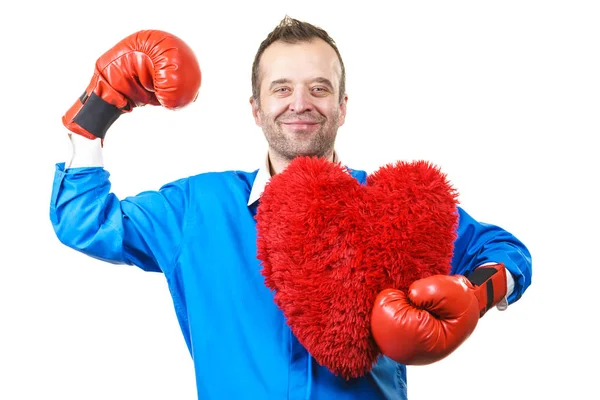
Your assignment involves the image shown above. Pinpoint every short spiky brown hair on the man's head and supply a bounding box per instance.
[252,15,346,104]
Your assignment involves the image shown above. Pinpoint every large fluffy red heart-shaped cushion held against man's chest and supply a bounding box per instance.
[256,157,458,379]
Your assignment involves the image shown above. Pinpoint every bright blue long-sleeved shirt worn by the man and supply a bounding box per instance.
[50,163,531,400]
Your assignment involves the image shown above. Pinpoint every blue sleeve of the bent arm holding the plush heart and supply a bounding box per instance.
[452,207,532,304]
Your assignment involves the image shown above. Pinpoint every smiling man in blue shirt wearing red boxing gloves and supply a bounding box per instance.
[50,17,531,400]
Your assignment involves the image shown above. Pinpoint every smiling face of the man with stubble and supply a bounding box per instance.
[250,39,348,161]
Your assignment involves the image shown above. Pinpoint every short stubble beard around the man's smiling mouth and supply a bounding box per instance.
[259,110,340,161]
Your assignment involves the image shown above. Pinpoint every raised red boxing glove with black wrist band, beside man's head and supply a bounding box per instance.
[62,30,202,139]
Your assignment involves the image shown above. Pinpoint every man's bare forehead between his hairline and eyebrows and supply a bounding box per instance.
[259,39,341,87]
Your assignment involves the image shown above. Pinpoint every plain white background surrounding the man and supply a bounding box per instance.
[0,0,600,400]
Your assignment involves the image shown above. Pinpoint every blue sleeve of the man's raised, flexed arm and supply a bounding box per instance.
[50,161,189,272]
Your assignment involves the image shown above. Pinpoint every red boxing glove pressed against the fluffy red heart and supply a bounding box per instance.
[371,264,507,365]
